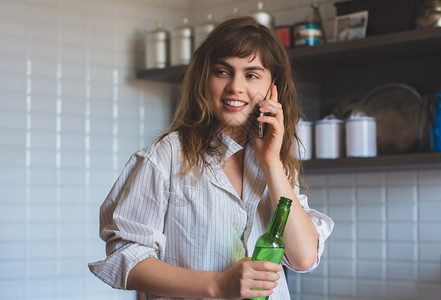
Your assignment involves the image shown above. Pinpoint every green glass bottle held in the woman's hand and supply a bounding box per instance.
[249,197,292,300]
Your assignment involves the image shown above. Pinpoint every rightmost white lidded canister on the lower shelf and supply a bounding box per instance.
[346,114,377,157]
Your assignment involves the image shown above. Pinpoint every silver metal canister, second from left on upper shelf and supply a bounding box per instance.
[170,18,193,66]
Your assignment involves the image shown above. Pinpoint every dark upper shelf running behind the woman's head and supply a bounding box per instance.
[137,28,441,83]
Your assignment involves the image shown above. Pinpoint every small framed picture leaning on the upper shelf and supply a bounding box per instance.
[335,10,369,42]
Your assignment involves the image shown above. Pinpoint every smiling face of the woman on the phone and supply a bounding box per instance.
[208,55,271,137]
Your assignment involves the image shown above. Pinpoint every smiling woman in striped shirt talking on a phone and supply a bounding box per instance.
[90,17,333,299]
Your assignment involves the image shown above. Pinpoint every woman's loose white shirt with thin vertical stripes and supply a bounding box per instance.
[89,133,333,299]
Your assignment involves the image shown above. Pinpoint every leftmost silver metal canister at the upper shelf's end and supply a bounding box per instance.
[145,22,170,69]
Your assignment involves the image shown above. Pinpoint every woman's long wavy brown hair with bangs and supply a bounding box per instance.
[159,17,301,186]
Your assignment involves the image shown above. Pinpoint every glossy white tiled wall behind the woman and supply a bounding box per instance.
[0,0,441,300]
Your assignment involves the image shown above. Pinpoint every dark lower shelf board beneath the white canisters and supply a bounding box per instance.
[303,152,441,175]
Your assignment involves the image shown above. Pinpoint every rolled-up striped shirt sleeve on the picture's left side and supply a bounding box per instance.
[89,153,168,289]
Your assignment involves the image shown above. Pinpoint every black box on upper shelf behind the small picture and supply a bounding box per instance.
[334,0,416,36]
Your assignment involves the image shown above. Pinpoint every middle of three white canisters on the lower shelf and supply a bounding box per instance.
[315,116,344,159]
